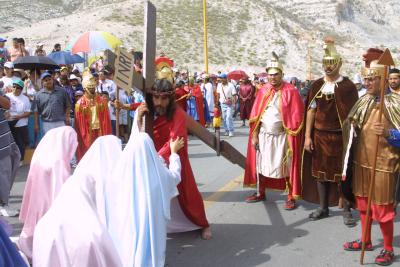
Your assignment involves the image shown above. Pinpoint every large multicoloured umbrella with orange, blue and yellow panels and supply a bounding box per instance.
[67,31,122,54]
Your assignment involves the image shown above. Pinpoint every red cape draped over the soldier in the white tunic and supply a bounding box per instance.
[243,82,304,197]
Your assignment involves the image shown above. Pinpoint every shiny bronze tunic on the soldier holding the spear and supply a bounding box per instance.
[353,108,399,205]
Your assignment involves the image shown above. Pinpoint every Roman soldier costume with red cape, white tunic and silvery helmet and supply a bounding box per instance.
[243,53,304,210]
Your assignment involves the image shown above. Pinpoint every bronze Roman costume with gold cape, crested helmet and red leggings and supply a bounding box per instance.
[343,48,400,266]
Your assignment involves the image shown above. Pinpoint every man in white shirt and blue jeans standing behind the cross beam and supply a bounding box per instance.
[217,74,237,137]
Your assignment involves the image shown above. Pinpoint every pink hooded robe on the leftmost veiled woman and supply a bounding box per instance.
[18,126,78,258]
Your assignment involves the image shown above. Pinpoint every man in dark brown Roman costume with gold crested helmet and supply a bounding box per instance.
[302,39,358,225]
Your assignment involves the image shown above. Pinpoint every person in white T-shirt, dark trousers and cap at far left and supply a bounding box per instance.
[6,80,31,165]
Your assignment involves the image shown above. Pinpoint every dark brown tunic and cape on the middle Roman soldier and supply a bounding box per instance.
[301,77,358,206]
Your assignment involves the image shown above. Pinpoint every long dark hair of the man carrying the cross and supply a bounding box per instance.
[146,79,176,121]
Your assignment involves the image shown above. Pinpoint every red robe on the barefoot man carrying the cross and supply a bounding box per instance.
[154,107,209,228]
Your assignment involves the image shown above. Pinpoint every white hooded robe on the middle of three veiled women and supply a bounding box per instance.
[32,135,122,267]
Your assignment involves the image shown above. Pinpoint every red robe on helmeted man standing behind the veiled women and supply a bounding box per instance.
[75,95,112,160]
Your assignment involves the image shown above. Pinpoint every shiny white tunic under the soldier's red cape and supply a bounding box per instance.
[256,94,291,178]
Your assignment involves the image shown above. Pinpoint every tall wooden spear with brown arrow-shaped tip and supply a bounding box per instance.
[360,49,394,265]
